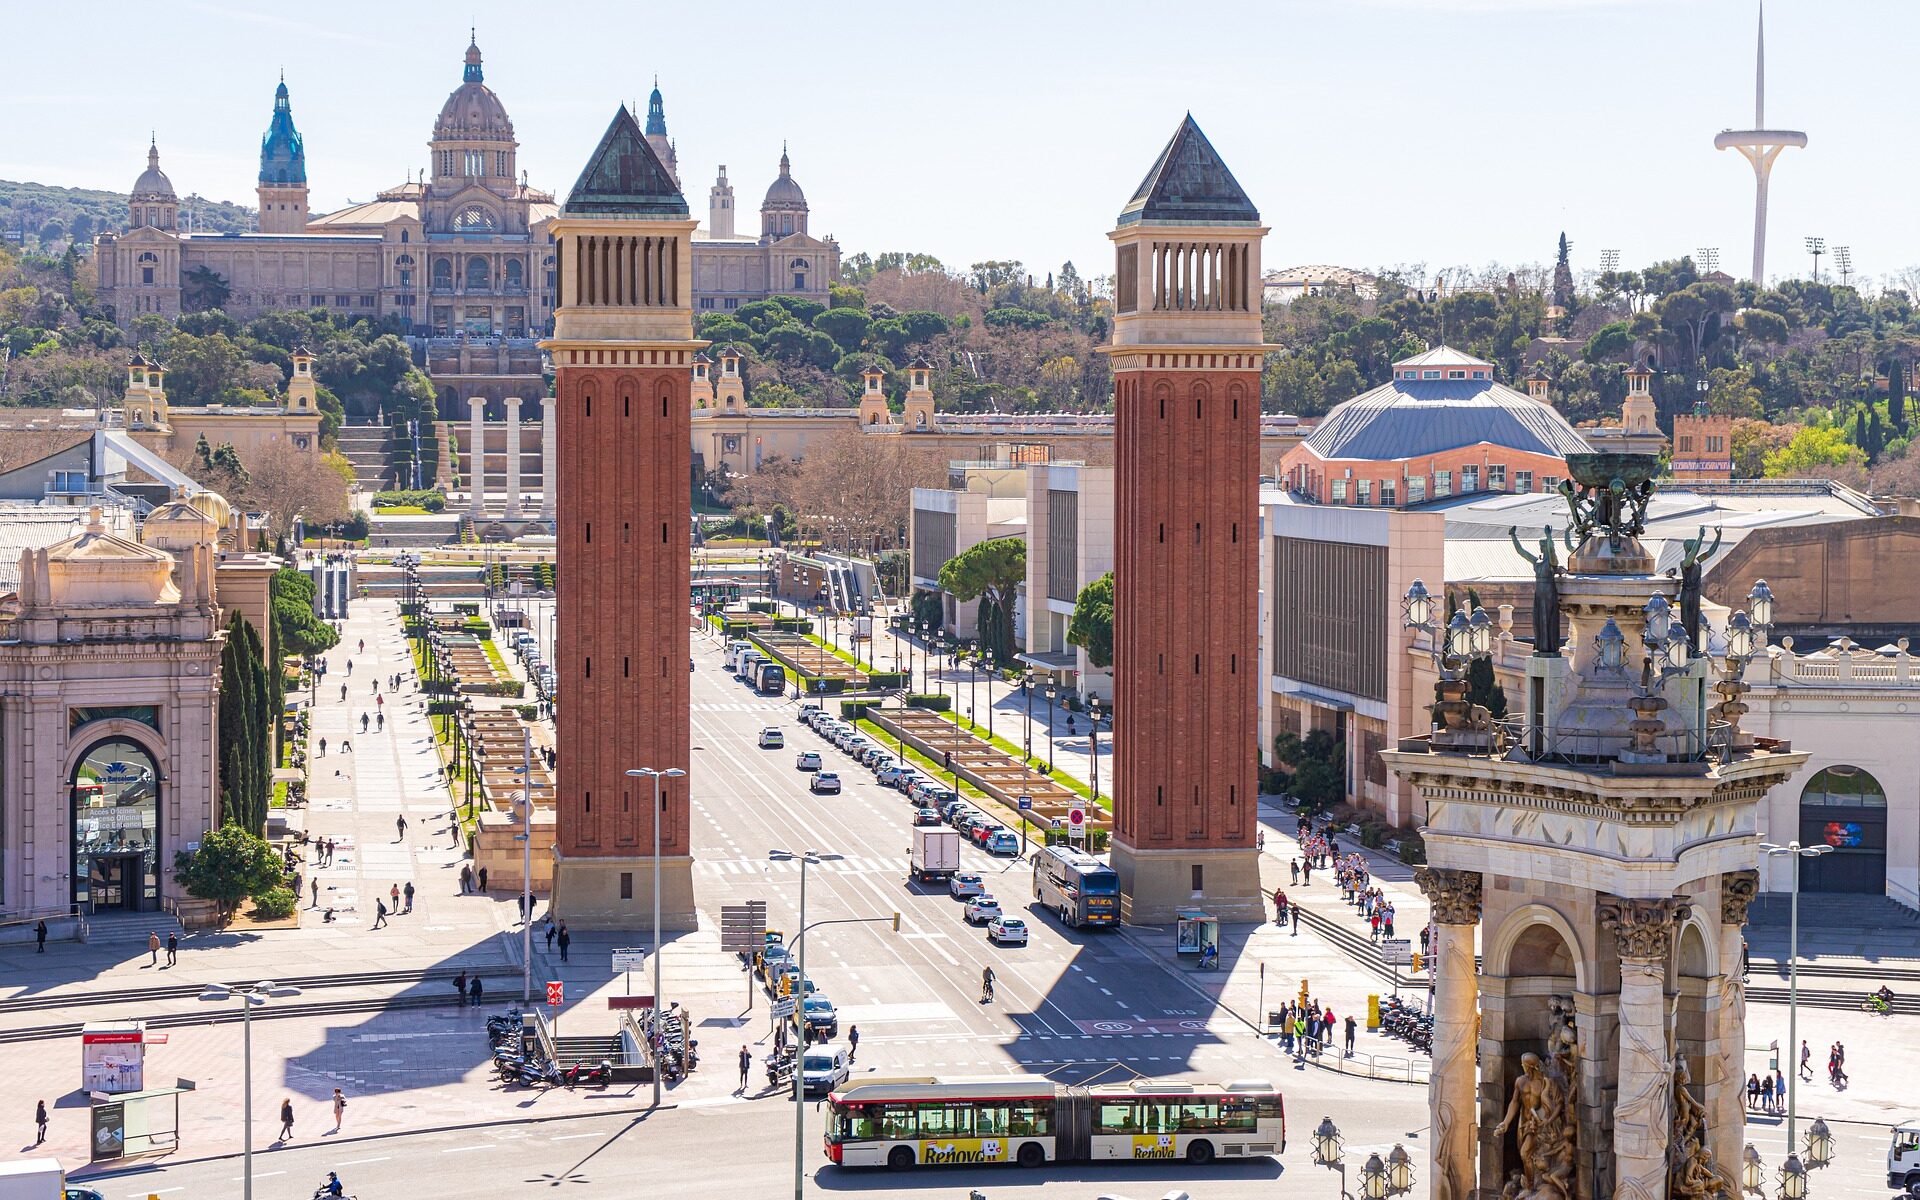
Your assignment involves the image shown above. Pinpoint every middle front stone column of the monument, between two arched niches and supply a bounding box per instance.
[1597,897,1688,1200]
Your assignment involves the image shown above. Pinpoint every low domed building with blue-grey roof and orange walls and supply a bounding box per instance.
[1281,346,1588,509]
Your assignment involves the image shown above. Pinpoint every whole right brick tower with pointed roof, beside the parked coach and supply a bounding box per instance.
[1108,117,1267,925]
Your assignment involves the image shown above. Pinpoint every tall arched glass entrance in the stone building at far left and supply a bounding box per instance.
[71,737,159,912]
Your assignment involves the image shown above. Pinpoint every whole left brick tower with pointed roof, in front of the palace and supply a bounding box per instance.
[541,108,705,929]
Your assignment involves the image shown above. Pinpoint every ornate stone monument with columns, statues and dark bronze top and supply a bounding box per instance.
[1382,455,1807,1200]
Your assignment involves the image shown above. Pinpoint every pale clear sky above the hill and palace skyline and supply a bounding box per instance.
[0,0,1920,288]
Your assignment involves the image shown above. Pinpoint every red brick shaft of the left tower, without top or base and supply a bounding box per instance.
[555,367,693,858]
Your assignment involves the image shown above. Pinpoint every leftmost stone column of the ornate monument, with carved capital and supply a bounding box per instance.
[1413,866,1480,1200]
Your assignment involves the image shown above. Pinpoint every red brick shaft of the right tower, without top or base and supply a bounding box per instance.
[1114,369,1260,849]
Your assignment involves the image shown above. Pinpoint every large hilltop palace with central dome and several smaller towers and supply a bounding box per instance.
[96,42,839,415]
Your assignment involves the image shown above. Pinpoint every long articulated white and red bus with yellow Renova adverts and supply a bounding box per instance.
[826,1075,1286,1171]
